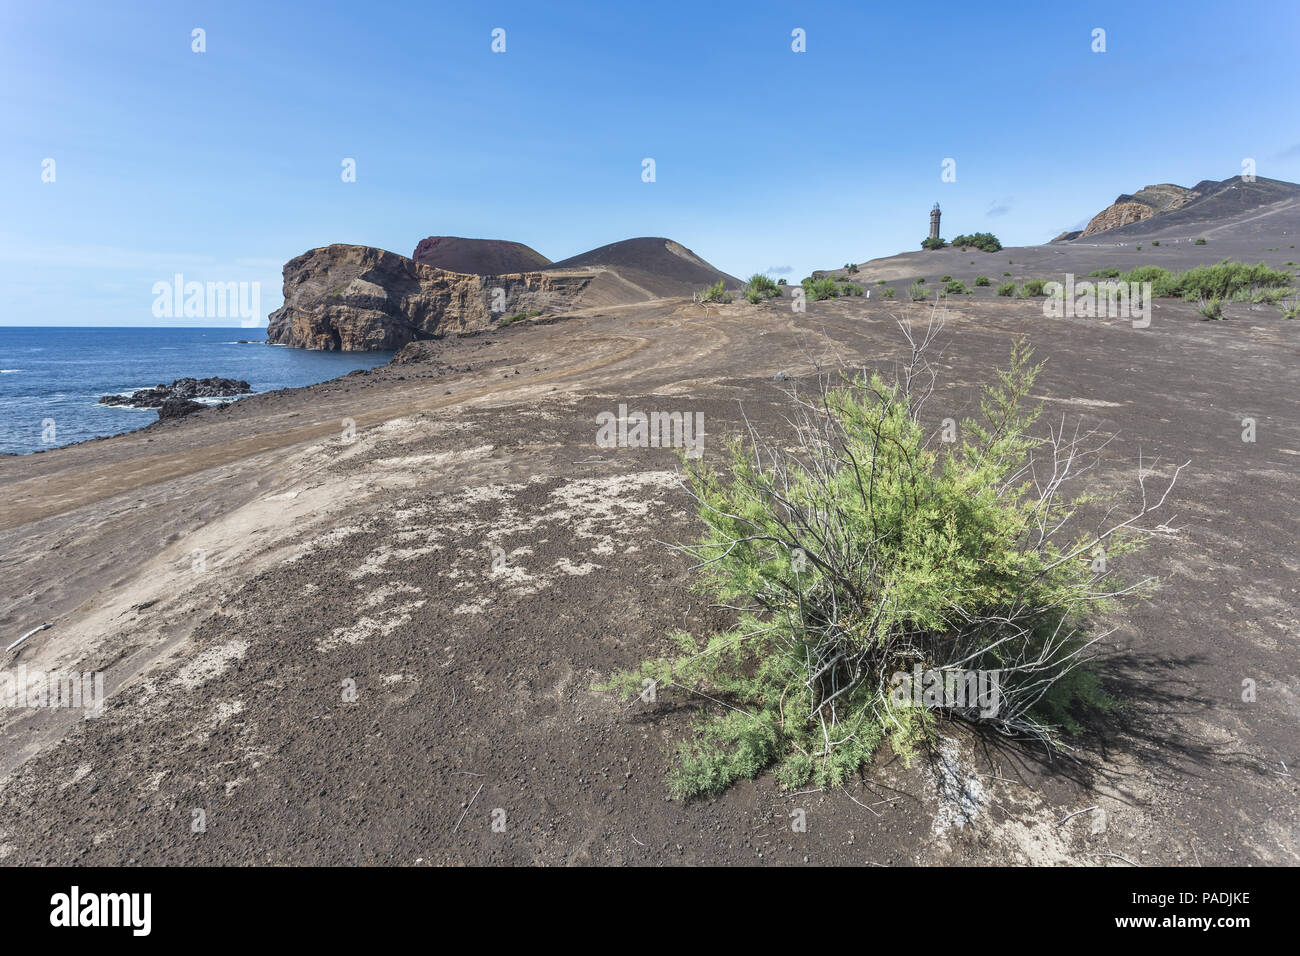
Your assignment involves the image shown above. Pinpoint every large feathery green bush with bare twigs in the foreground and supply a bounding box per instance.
[602,343,1177,799]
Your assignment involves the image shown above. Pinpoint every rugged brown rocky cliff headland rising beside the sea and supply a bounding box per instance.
[267,245,590,351]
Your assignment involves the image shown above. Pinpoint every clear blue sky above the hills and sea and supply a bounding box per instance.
[0,0,1300,325]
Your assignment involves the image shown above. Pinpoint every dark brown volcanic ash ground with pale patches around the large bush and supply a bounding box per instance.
[0,293,1300,865]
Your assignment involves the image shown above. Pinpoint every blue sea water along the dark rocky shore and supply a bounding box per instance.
[0,326,393,454]
